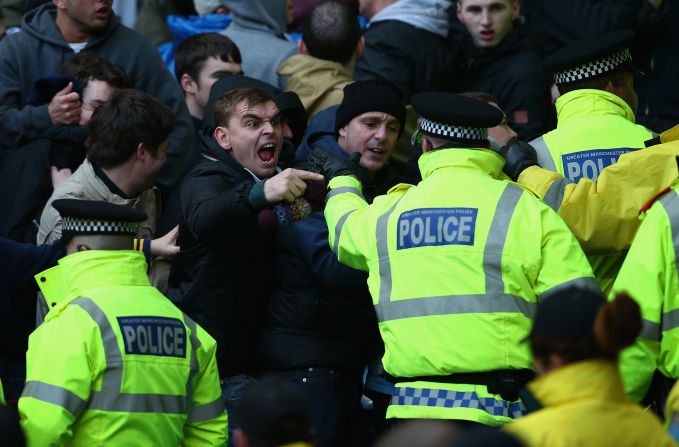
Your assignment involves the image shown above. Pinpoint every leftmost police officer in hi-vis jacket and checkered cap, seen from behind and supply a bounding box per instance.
[19,199,227,446]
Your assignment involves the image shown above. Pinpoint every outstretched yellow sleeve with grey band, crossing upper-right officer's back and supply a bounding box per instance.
[518,141,679,255]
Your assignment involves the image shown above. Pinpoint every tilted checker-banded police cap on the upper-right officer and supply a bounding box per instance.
[542,31,634,85]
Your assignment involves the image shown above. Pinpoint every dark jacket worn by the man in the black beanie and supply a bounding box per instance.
[259,211,379,374]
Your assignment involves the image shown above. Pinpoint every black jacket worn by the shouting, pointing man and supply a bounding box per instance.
[168,139,274,377]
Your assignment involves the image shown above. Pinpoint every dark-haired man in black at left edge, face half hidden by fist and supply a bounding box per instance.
[0,51,130,247]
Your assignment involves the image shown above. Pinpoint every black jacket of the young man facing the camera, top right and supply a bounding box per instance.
[452,20,556,141]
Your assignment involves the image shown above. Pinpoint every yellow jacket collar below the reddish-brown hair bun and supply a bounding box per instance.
[528,359,627,407]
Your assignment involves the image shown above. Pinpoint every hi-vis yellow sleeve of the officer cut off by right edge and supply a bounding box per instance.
[610,192,679,402]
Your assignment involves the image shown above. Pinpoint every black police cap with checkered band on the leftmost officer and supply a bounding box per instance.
[52,199,148,236]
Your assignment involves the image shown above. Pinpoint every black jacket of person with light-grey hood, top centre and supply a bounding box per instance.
[354,20,462,103]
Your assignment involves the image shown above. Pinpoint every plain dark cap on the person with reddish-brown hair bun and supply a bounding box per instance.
[530,287,606,340]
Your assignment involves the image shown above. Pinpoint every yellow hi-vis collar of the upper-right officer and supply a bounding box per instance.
[556,89,635,127]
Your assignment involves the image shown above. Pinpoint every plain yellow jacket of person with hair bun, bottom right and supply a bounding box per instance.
[503,360,676,447]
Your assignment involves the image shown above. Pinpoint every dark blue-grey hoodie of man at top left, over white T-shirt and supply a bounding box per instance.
[0,3,193,187]
